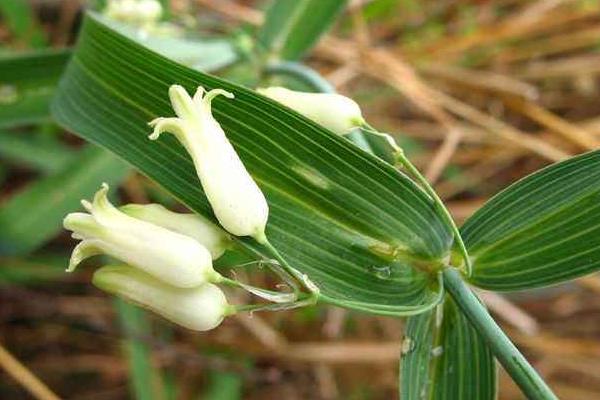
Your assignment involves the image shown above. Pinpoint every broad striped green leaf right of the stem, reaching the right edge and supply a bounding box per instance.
[462,151,600,290]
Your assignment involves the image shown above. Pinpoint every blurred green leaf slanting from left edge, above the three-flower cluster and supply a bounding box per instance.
[0,146,128,255]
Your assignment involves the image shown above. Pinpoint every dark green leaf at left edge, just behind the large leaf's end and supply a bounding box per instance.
[0,50,70,127]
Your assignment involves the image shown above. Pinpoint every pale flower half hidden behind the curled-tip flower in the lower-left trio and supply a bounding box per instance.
[119,204,231,260]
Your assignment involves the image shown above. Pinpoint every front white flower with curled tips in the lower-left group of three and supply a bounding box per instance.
[63,184,220,287]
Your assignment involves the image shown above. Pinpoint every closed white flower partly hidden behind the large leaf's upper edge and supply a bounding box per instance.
[256,87,364,135]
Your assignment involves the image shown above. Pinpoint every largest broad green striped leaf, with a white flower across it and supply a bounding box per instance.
[53,14,452,315]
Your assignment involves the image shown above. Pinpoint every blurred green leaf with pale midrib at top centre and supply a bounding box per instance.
[258,0,346,60]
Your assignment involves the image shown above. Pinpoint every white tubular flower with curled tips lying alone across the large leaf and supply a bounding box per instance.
[149,85,269,243]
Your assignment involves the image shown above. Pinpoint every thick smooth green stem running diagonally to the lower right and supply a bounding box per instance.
[443,268,558,400]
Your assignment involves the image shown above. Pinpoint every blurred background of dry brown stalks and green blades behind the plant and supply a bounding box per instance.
[0,0,600,400]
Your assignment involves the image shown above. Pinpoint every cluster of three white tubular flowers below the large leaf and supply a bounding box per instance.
[64,184,233,331]
